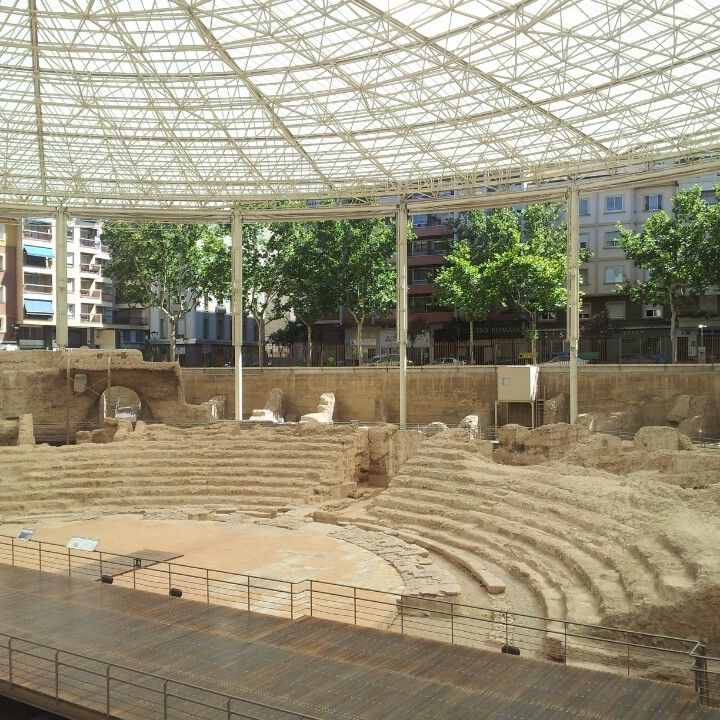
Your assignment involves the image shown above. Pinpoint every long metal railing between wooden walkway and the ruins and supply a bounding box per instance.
[0,535,720,705]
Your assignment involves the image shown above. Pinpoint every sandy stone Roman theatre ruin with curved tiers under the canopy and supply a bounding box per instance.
[0,350,720,680]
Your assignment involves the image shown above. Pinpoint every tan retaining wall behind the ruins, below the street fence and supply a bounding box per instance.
[183,365,720,434]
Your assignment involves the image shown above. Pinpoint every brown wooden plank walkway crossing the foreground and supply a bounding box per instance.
[0,565,720,720]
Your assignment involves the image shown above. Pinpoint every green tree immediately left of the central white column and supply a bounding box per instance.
[336,218,396,365]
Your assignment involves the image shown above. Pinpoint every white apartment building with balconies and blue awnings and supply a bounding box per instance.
[5,218,147,349]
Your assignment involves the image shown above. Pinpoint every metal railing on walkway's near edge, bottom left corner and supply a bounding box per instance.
[0,633,326,720]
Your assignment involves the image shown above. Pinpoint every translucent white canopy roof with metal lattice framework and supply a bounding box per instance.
[0,0,720,208]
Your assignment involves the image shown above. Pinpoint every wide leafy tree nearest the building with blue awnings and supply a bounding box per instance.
[103,221,224,360]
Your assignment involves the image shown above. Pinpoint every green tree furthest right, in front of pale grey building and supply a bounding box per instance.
[618,185,720,363]
